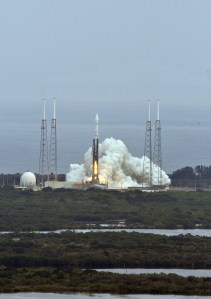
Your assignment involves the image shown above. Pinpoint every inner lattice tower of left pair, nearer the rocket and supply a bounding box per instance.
[49,98,57,181]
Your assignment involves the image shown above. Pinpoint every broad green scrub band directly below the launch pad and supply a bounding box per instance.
[0,189,211,231]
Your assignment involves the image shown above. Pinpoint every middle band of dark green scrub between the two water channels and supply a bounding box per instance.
[0,232,211,269]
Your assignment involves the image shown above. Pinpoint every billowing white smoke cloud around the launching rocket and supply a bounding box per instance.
[66,138,170,188]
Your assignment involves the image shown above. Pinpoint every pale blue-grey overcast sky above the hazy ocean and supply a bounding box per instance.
[0,0,211,123]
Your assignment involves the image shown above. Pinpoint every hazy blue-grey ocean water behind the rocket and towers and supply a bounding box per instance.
[0,120,211,173]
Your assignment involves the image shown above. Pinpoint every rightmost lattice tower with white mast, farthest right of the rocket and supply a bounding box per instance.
[153,100,163,186]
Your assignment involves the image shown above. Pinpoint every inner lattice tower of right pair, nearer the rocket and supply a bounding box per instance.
[143,100,152,187]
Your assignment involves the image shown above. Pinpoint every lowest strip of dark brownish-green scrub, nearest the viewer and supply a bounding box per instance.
[0,267,211,295]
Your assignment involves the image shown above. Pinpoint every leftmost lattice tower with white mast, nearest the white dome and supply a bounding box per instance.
[39,99,48,186]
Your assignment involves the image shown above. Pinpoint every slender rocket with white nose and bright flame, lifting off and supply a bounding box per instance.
[92,114,99,184]
